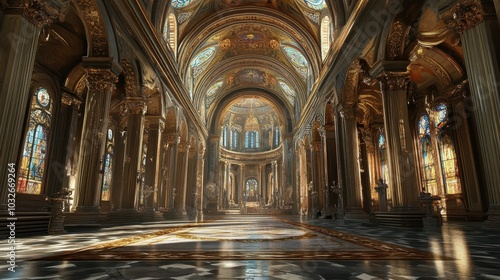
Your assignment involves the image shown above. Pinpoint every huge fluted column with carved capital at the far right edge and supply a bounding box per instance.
[454,1,500,226]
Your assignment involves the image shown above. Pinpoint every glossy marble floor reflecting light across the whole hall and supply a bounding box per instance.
[0,215,500,280]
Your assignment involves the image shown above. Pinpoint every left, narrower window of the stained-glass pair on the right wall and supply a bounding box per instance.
[418,114,438,195]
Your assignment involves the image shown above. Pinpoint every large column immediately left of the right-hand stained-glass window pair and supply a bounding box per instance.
[375,68,420,210]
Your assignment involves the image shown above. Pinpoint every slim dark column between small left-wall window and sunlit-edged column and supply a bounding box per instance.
[111,107,128,211]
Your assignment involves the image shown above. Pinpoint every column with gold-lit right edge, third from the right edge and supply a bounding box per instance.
[339,106,368,219]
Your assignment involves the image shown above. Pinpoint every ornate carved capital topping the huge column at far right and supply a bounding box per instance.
[443,0,484,45]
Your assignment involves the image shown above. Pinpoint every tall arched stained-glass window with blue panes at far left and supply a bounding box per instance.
[17,87,52,194]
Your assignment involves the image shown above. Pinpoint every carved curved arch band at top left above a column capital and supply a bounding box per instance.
[76,0,109,57]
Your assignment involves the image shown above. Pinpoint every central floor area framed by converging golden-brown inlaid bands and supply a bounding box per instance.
[38,216,450,261]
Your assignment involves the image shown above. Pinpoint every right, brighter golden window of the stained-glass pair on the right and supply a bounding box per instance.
[434,103,462,194]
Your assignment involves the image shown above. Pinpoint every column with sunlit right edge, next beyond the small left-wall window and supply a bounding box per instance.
[119,97,146,212]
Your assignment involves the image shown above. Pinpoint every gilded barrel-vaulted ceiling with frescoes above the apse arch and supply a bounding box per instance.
[171,0,329,127]
